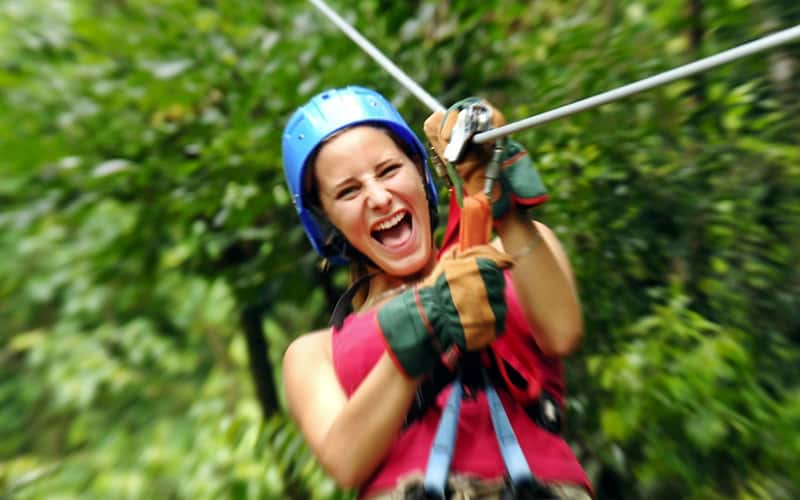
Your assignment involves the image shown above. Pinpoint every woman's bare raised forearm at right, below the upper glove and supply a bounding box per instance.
[495,210,583,356]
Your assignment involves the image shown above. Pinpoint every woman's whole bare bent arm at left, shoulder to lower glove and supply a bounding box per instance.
[283,330,419,488]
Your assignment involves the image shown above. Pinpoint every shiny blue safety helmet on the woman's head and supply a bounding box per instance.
[283,86,439,264]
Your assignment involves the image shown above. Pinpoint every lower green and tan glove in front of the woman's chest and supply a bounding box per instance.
[377,245,512,377]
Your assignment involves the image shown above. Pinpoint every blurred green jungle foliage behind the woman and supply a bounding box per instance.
[0,0,800,500]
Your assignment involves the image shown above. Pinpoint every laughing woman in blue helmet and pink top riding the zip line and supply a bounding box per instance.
[283,87,591,498]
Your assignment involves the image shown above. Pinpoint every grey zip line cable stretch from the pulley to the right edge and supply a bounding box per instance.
[472,25,800,144]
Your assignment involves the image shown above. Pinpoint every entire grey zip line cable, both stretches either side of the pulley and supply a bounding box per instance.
[309,0,800,144]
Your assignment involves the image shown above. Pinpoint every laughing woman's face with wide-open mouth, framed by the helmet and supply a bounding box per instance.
[314,126,433,276]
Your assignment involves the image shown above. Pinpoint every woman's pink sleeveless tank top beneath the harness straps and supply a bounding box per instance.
[333,274,591,497]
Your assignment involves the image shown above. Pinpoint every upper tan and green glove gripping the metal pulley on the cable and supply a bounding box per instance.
[423,97,548,219]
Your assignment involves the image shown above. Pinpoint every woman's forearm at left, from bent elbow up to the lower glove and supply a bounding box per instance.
[318,354,419,487]
